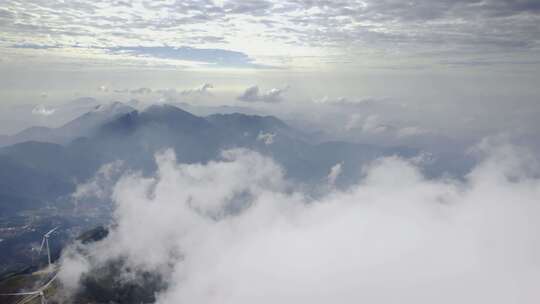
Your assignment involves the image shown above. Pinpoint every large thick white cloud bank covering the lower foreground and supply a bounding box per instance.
[60,144,540,304]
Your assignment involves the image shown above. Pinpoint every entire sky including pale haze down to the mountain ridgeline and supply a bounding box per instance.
[0,0,540,147]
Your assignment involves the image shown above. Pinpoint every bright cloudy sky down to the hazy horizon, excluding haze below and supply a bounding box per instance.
[0,0,540,103]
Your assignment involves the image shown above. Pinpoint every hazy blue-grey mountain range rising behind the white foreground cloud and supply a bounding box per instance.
[0,103,430,217]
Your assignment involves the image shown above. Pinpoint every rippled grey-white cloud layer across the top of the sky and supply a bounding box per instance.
[0,0,540,68]
